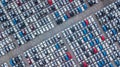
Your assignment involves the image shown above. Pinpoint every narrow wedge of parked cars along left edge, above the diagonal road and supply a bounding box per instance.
[0,6,16,57]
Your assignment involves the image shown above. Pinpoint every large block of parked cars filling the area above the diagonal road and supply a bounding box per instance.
[0,0,98,56]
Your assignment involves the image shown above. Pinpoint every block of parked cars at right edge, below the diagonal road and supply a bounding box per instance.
[95,0,120,44]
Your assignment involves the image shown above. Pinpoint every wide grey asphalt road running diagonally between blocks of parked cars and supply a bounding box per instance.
[0,0,118,67]
